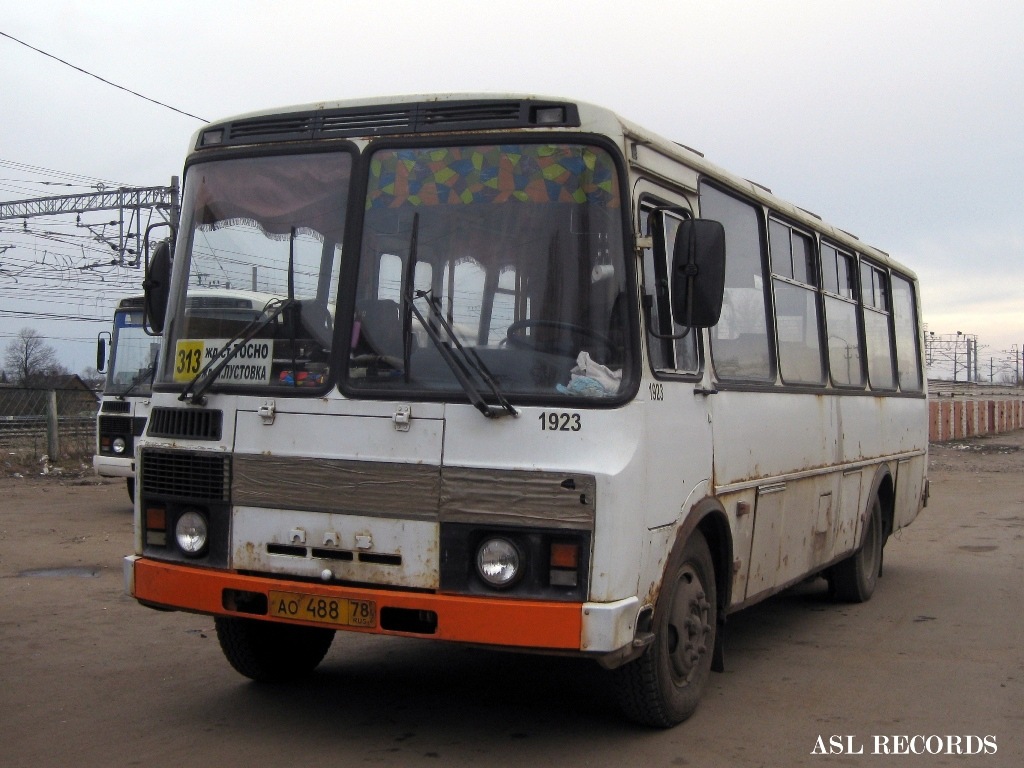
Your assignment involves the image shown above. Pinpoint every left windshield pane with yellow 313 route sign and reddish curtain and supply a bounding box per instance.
[161,153,352,389]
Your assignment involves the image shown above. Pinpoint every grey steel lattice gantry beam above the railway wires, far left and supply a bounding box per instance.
[0,176,180,267]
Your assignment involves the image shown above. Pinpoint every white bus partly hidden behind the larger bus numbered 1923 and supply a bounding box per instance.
[92,296,160,500]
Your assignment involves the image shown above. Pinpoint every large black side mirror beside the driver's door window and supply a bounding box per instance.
[672,219,725,328]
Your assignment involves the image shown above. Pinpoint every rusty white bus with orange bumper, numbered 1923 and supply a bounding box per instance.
[125,95,928,727]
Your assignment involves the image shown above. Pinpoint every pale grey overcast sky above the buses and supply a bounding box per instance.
[0,0,1024,380]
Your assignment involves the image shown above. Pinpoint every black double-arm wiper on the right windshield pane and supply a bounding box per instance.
[402,213,519,419]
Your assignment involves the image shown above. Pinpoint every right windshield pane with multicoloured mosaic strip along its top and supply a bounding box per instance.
[345,143,631,401]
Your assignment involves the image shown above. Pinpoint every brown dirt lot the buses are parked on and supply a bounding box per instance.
[0,432,1024,768]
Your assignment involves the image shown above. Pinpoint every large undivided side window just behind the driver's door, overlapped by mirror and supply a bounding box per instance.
[700,182,775,382]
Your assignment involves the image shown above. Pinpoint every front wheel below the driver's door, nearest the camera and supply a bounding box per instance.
[614,530,718,728]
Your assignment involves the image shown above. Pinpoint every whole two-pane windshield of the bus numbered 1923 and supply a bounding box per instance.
[162,143,633,403]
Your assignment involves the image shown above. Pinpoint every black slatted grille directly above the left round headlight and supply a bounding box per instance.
[139,450,231,502]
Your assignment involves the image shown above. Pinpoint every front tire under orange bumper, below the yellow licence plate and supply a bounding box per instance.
[214,616,334,683]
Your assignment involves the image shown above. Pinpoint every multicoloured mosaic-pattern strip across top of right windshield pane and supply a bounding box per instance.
[367,144,620,209]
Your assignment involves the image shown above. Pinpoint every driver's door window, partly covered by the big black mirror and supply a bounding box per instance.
[640,203,700,374]
